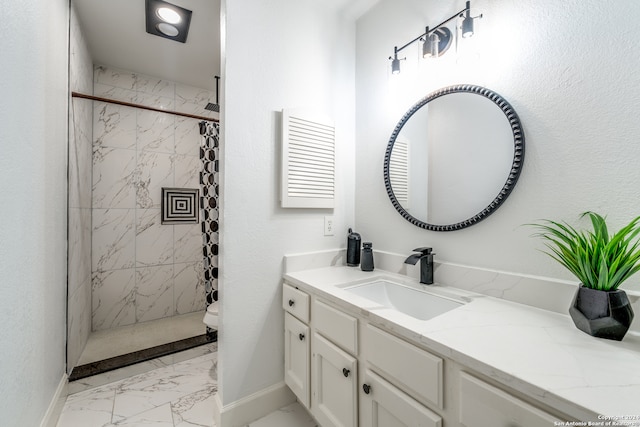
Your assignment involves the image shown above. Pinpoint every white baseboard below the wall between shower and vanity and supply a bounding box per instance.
[214,382,296,427]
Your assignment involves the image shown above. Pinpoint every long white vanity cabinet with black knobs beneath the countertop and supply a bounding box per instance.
[283,270,597,427]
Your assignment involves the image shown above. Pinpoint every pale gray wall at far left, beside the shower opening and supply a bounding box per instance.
[0,0,69,426]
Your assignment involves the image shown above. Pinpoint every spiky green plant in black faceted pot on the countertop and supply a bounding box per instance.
[531,212,640,341]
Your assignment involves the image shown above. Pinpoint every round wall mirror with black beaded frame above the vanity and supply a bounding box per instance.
[384,85,524,231]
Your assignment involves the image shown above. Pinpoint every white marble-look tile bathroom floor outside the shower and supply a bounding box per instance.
[57,343,316,427]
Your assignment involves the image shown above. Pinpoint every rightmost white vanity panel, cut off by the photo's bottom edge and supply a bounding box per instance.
[460,372,560,427]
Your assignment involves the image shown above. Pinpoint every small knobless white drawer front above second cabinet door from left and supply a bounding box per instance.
[312,300,358,355]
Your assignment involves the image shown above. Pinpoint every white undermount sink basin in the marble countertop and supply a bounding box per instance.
[344,280,463,320]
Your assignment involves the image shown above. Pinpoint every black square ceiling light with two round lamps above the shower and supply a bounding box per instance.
[145,0,192,43]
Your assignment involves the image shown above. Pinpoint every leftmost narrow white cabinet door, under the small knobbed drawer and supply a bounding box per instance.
[284,313,310,408]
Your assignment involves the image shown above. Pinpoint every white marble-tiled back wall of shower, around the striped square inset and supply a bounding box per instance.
[92,66,215,330]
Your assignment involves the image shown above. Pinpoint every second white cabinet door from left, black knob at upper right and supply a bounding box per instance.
[311,333,358,427]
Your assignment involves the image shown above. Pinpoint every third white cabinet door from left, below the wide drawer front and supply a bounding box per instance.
[360,369,442,427]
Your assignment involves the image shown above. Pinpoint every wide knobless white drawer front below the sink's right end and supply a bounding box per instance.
[363,325,443,408]
